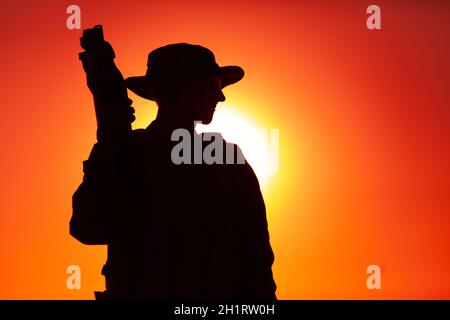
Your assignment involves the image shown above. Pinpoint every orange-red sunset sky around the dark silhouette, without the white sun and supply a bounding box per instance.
[0,0,450,299]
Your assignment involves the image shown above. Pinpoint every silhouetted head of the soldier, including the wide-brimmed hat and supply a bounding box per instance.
[126,43,244,124]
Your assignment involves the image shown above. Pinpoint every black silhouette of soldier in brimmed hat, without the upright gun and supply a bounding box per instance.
[70,43,276,299]
